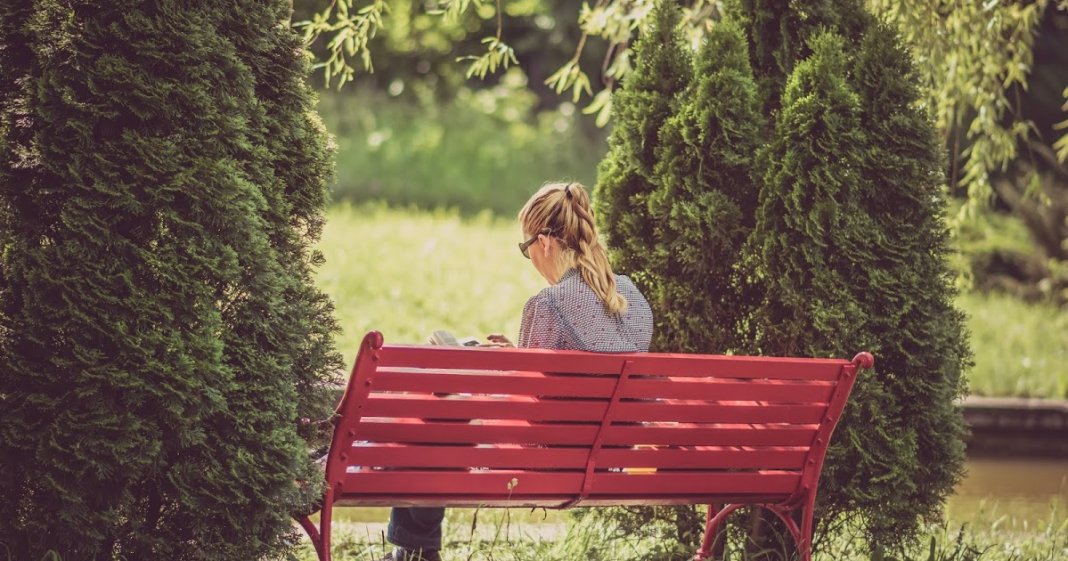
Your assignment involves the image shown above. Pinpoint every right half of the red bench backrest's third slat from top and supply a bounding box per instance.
[612,401,827,424]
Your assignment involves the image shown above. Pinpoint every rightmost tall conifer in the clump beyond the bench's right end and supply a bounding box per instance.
[827,24,971,543]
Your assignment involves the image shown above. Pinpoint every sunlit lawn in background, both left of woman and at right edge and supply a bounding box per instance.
[318,205,1068,398]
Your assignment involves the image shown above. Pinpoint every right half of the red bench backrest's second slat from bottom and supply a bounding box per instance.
[597,447,807,470]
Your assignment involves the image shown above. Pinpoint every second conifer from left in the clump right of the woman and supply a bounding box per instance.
[646,19,764,353]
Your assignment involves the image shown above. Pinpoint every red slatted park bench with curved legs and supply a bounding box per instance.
[300,332,874,561]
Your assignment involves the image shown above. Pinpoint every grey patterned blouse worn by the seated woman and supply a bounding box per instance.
[518,268,653,353]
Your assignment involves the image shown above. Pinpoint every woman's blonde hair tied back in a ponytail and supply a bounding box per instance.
[519,183,627,314]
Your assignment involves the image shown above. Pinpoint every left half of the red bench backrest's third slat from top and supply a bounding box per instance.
[362,394,608,421]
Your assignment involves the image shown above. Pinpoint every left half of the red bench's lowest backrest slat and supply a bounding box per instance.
[342,470,583,498]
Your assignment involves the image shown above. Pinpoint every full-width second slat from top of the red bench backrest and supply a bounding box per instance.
[372,369,834,403]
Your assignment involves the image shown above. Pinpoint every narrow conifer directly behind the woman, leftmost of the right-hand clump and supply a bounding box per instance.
[594,2,690,279]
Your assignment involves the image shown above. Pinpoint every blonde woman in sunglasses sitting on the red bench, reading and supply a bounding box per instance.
[382,183,653,561]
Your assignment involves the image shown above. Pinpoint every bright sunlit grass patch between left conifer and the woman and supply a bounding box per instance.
[309,205,546,364]
